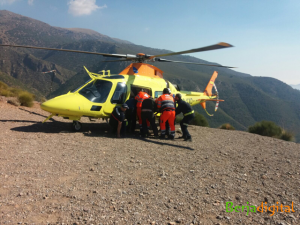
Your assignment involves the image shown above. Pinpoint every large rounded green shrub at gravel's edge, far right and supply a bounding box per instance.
[248,121,282,138]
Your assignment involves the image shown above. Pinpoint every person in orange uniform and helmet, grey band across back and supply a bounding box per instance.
[156,88,175,139]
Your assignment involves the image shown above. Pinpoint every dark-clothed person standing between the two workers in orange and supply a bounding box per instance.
[141,97,158,137]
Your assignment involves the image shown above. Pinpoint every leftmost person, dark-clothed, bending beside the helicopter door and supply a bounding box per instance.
[109,103,129,138]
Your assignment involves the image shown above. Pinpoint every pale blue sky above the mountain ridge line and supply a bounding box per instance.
[0,0,300,84]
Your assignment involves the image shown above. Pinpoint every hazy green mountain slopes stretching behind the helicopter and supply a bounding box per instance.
[0,10,300,141]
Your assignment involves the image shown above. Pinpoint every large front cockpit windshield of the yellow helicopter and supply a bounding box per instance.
[79,80,112,103]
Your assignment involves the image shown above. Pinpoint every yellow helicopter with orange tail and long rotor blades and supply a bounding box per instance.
[0,42,234,131]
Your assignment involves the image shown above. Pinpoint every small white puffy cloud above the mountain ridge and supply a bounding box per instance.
[68,0,107,16]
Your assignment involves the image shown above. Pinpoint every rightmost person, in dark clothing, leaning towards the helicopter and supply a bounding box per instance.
[175,93,195,141]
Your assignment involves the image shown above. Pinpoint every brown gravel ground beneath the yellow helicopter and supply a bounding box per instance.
[0,98,300,225]
